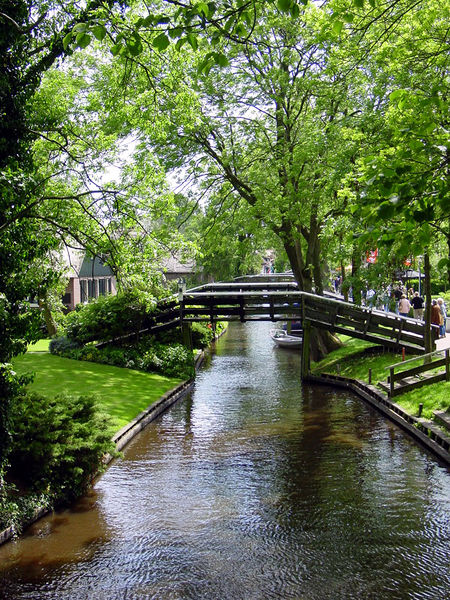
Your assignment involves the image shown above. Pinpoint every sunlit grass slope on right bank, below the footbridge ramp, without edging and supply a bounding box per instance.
[311,336,450,419]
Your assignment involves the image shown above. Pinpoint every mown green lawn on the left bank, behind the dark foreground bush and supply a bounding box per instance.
[13,353,181,429]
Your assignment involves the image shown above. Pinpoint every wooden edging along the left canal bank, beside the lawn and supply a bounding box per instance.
[0,351,205,546]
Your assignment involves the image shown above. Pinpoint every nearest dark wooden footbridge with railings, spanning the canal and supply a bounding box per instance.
[142,281,434,354]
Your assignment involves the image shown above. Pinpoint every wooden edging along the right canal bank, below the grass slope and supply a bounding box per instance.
[304,373,450,466]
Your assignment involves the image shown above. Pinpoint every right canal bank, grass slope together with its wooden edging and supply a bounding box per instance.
[307,338,450,465]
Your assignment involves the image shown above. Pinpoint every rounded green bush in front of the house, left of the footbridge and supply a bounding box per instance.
[62,291,155,344]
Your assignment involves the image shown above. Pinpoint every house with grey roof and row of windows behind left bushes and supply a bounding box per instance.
[63,248,117,310]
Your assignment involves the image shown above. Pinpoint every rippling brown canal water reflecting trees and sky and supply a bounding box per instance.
[0,323,450,600]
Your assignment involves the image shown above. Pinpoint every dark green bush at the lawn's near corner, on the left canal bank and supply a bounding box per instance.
[9,393,115,503]
